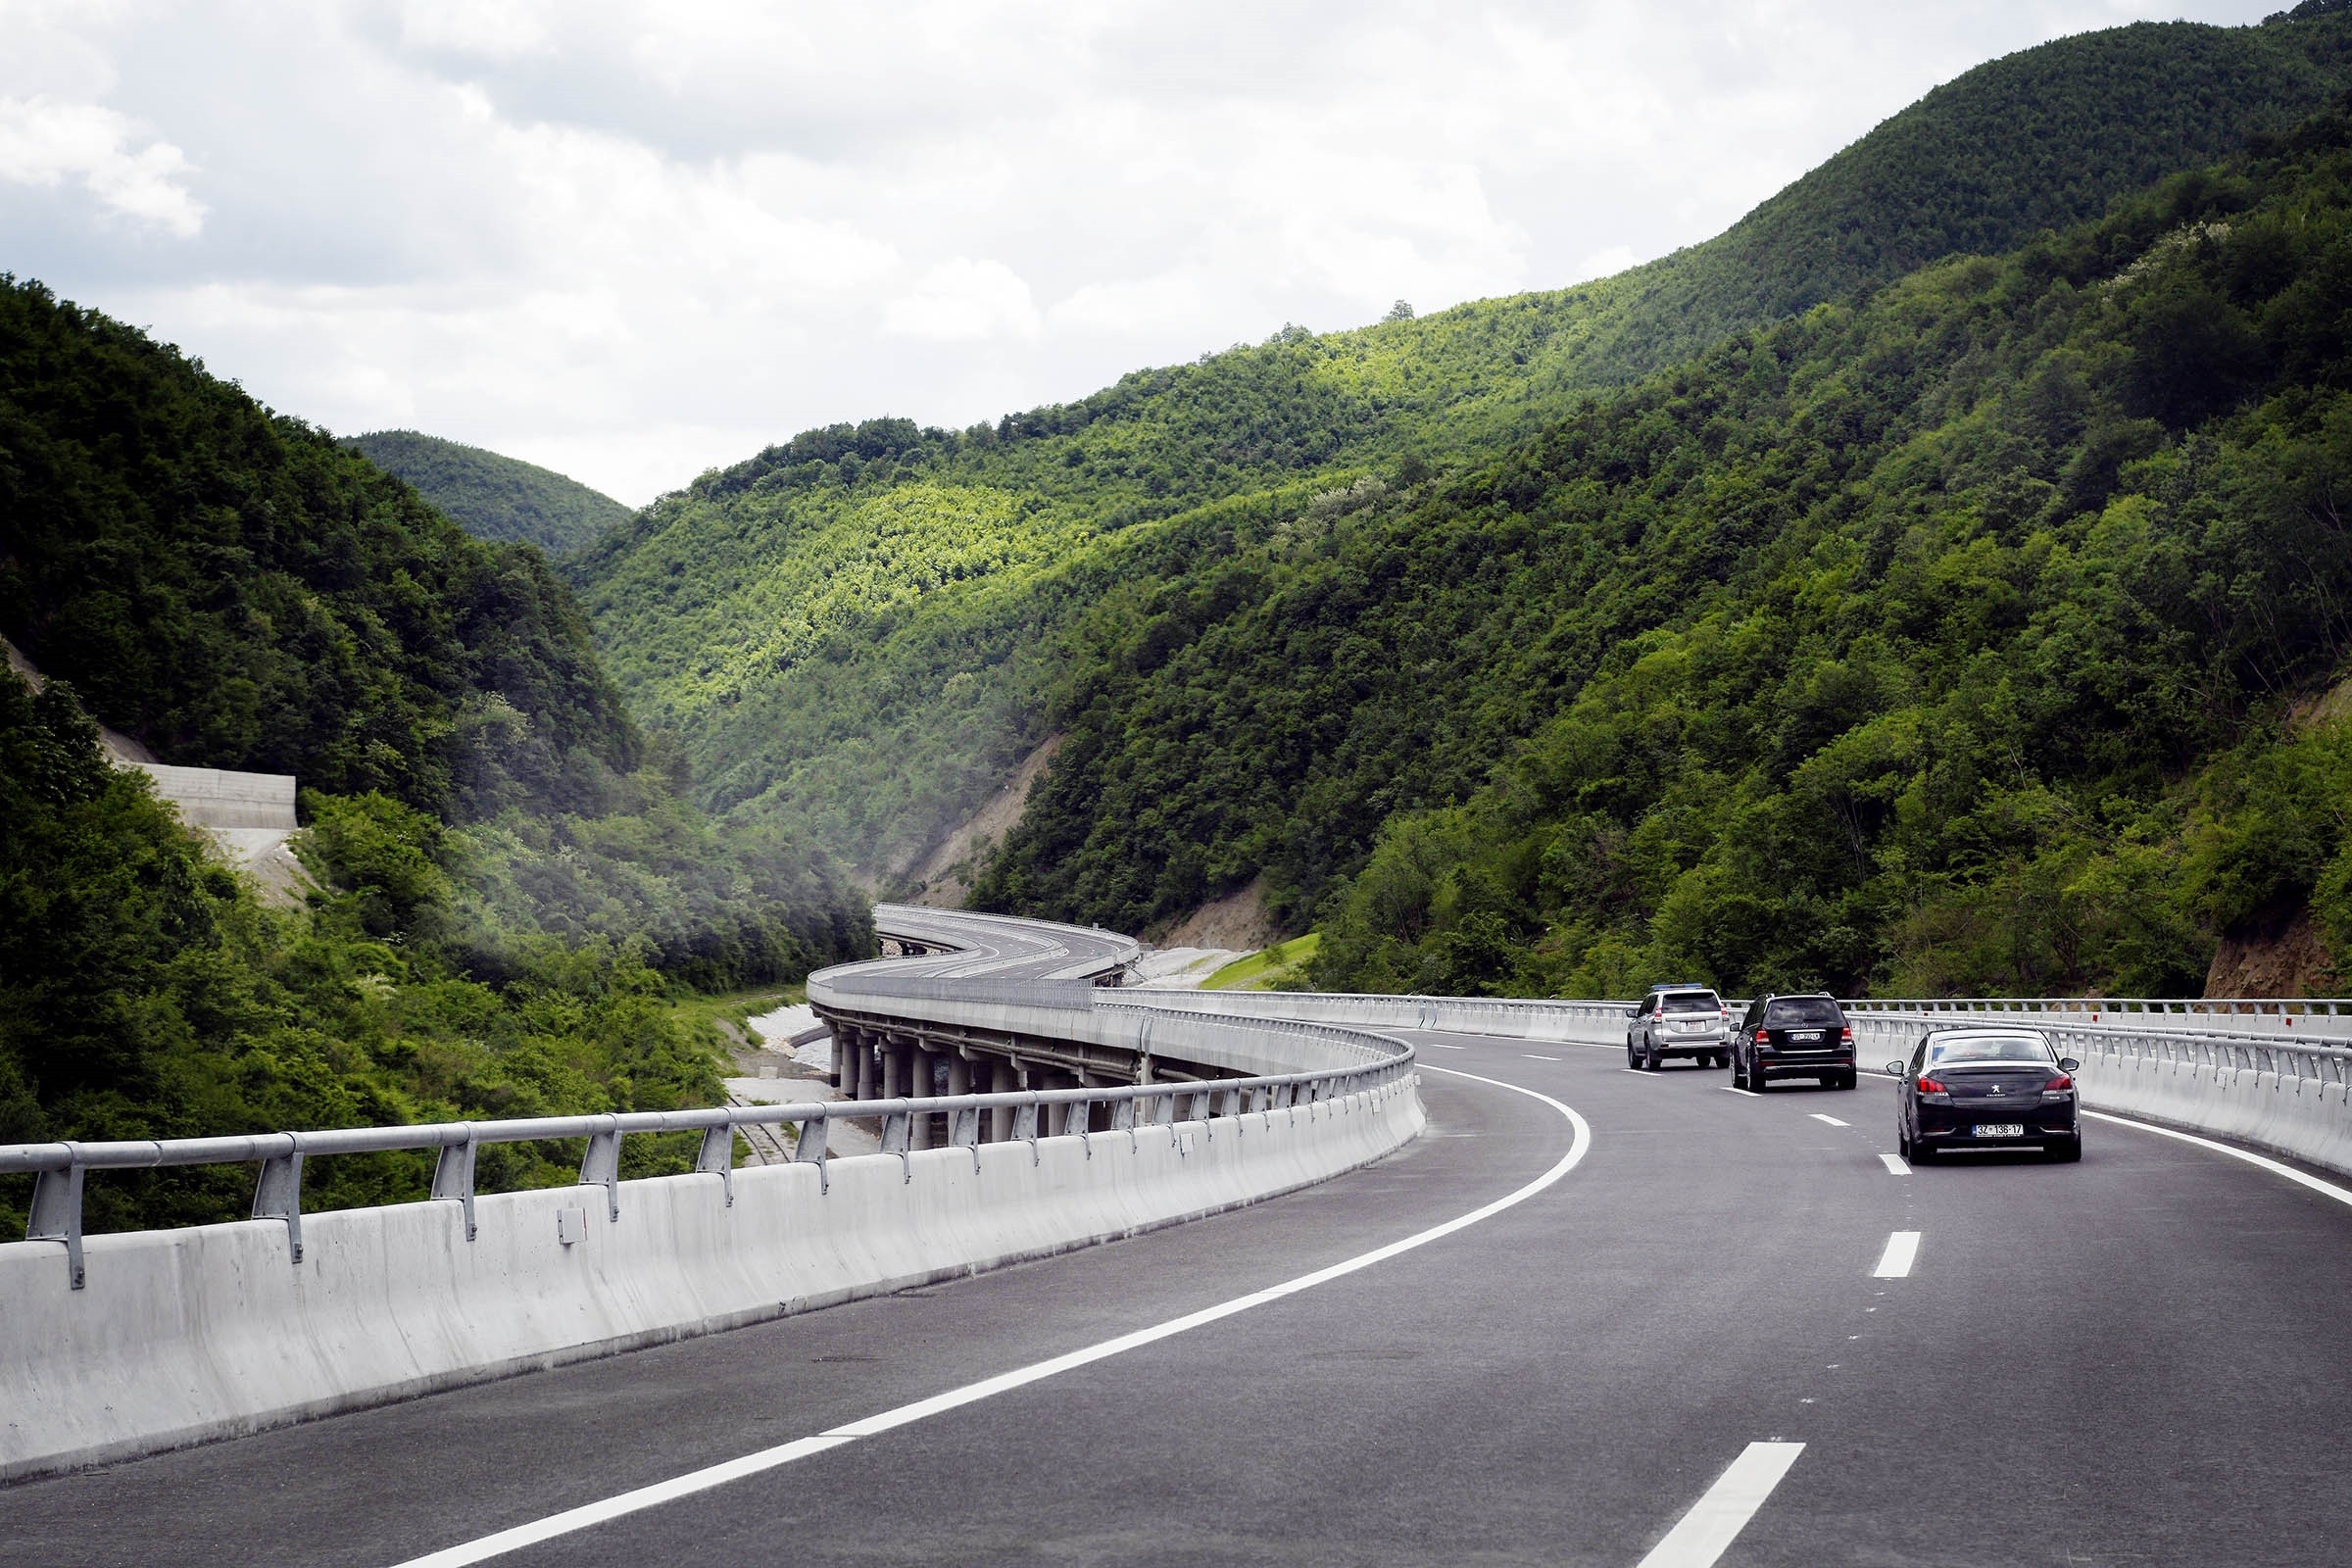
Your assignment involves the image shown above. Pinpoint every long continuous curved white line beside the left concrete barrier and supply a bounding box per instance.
[395,1065,1592,1568]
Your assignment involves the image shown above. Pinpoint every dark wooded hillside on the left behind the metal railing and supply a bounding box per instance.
[0,279,870,1232]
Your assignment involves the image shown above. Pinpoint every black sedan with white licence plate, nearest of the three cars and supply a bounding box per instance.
[1886,1027,2082,1163]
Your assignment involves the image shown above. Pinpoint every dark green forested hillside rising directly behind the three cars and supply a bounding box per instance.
[997,104,2352,995]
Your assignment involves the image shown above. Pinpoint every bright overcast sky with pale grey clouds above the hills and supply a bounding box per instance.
[0,0,2286,503]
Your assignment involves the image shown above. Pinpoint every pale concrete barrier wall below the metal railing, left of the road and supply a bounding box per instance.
[0,1077,1423,1479]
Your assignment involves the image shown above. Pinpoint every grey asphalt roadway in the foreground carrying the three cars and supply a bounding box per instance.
[0,1010,2352,1568]
